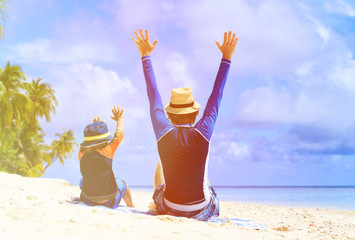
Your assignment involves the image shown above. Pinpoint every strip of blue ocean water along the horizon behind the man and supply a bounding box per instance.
[132,186,355,210]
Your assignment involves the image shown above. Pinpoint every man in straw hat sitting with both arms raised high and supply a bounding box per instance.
[132,29,238,220]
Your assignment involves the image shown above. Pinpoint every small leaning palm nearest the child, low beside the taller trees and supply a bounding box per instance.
[43,129,78,174]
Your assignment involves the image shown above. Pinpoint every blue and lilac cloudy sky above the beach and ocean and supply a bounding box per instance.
[0,0,355,186]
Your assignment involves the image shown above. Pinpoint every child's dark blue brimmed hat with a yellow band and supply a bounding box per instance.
[80,121,112,148]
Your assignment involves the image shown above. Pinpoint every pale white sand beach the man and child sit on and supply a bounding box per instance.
[0,173,355,240]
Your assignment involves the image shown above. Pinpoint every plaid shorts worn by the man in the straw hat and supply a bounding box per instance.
[153,183,219,221]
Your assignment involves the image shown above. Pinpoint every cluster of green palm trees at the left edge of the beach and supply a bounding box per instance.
[0,62,78,177]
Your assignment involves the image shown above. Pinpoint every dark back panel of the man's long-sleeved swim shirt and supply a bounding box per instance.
[158,126,209,204]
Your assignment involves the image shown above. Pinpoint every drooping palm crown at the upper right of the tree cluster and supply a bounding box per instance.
[24,78,58,122]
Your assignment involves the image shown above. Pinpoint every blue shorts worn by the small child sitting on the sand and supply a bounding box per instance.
[79,178,127,208]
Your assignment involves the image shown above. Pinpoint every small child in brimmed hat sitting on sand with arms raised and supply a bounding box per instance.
[79,106,134,208]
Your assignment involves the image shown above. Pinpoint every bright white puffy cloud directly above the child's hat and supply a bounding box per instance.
[44,62,136,132]
